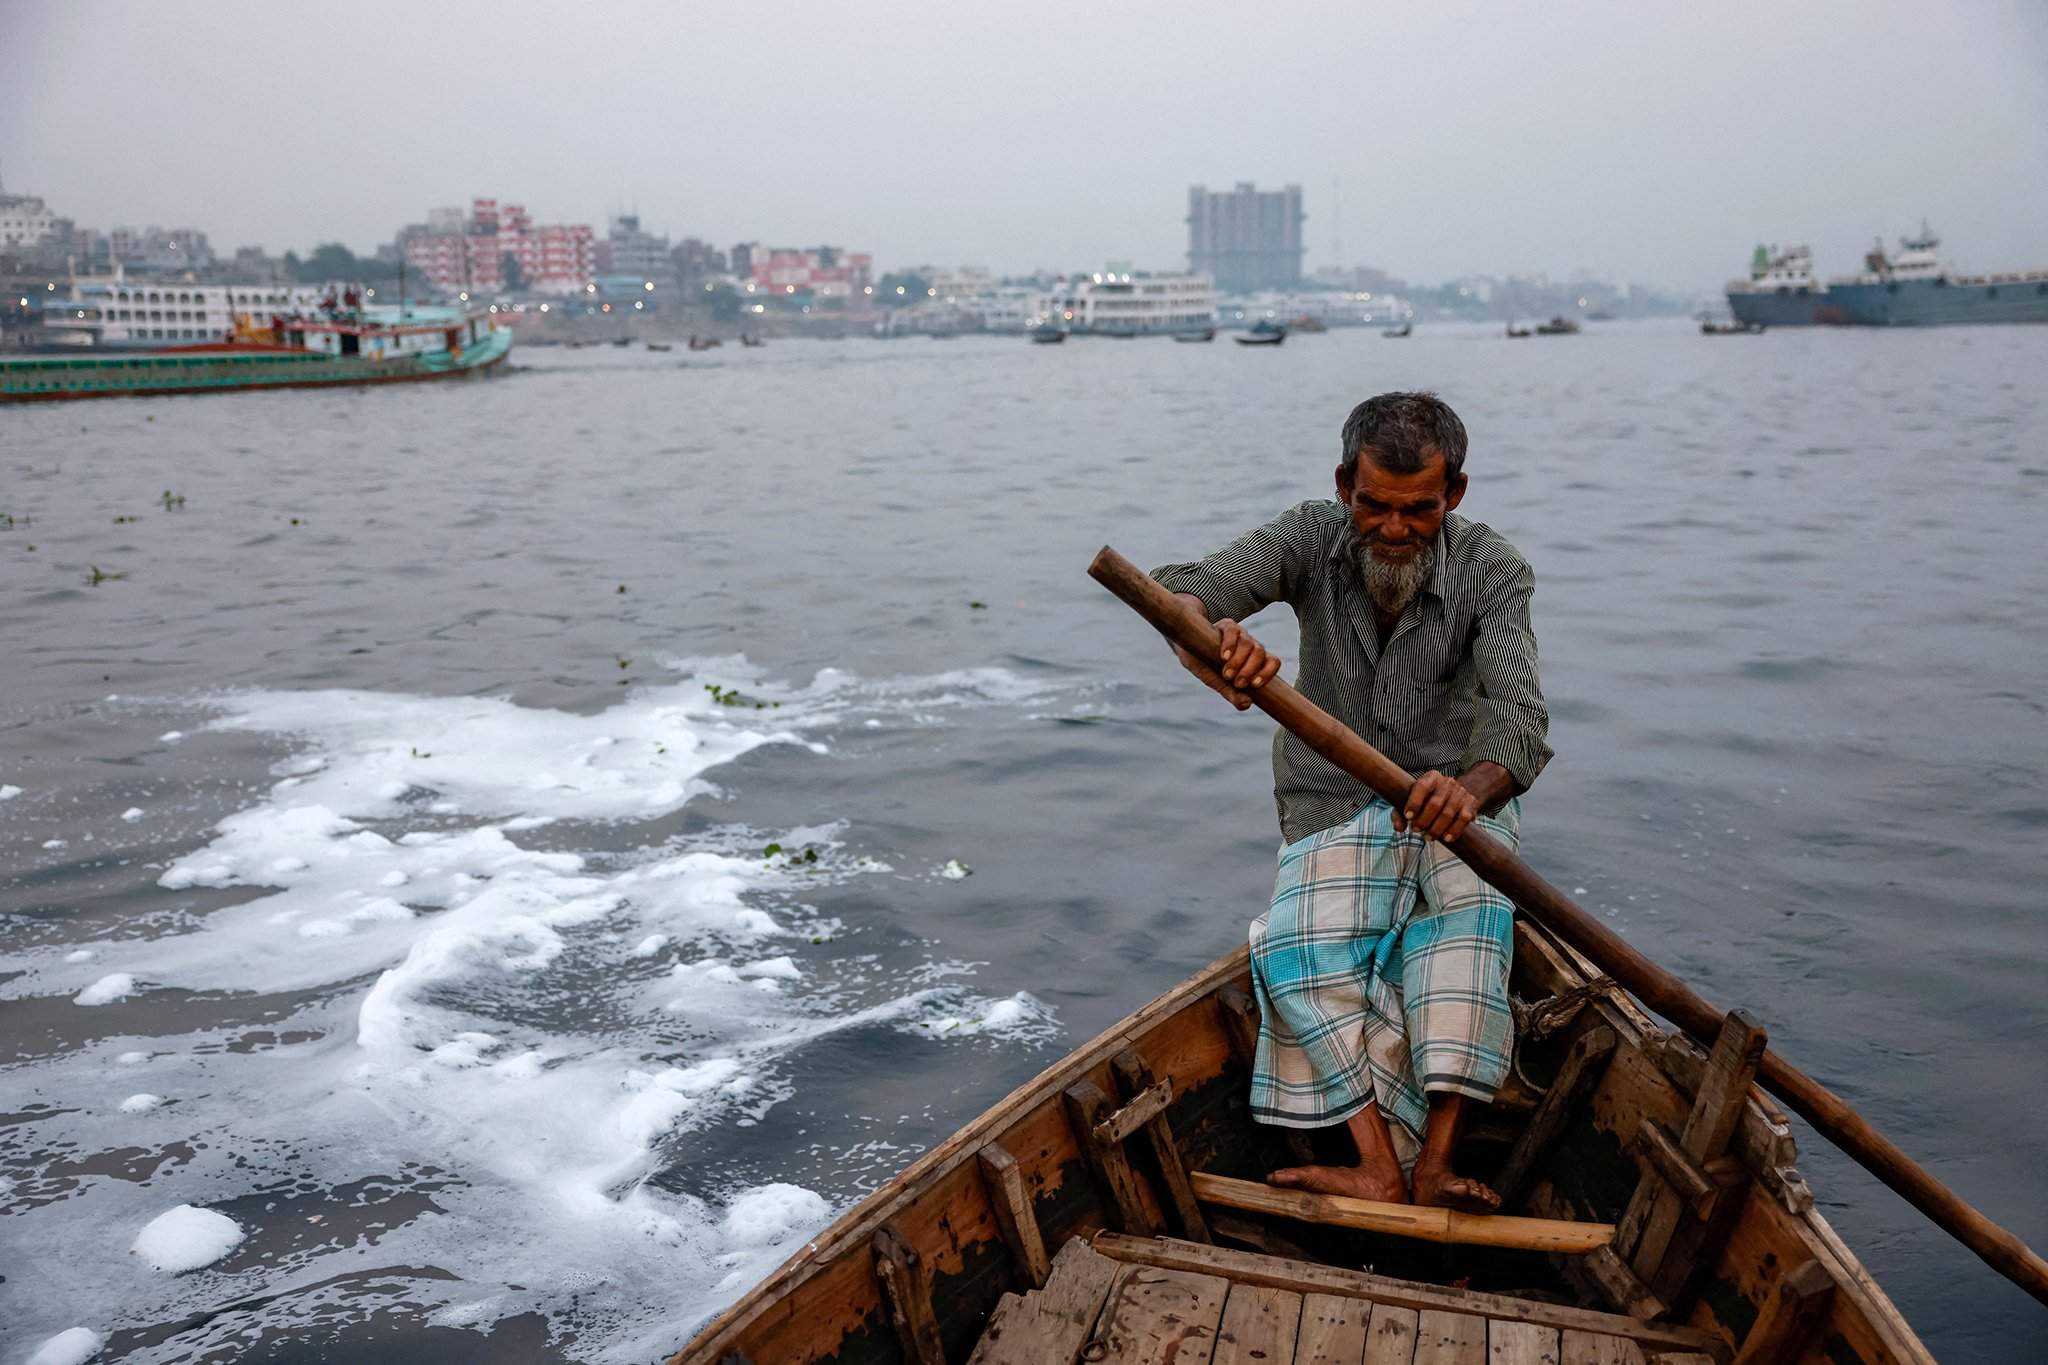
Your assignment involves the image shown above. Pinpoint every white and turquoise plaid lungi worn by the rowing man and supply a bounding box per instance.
[1251,800,1522,1166]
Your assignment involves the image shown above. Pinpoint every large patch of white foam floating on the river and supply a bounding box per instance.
[0,657,1057,1361]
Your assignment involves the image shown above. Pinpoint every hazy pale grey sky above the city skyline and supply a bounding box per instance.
[12,0,2048,289]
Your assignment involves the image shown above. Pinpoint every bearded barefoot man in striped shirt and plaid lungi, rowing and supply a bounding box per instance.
[1153,393,1550,1212]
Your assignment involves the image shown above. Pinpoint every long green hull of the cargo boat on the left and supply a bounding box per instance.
[0,327,512,403]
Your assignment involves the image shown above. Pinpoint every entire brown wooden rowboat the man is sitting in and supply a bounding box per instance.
[672,919,1931,1365]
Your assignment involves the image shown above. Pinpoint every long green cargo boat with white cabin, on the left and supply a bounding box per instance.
[0,305,512,403]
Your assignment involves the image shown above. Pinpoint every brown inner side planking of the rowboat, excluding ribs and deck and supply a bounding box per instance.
[672,921,1931,1365]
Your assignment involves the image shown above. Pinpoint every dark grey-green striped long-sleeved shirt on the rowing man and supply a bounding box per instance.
[1153,499,1550,843]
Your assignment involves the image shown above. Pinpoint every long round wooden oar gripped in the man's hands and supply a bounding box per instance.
[1087,546,2048,1304]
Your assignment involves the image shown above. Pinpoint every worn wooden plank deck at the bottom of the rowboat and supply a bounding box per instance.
[969,1232,1726,1365]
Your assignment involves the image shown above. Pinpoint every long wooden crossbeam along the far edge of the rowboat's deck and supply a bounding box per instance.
[1092,1232,1720,1351]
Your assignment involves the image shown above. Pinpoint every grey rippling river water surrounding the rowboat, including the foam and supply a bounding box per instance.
[0,323,2048,1361]
